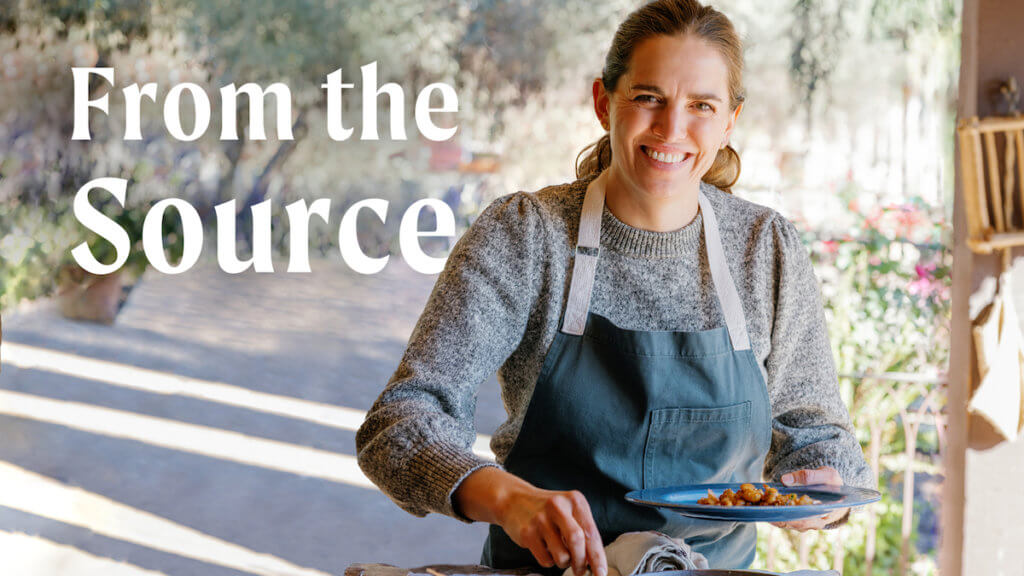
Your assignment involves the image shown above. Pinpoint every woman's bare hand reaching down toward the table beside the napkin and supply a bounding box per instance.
[454,467,608,576]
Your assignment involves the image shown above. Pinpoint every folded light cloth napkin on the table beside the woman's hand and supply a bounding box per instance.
[562,531,840,576]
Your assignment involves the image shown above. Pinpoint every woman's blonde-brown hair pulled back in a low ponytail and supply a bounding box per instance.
[577,0,745,192]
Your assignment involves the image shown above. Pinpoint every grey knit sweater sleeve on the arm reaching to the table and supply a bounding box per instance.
[355,193,543,523]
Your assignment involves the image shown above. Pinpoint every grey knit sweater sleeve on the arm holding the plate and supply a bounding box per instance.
[764,215,876,488]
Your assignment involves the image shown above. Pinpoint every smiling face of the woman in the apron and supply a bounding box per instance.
[594,35,742,198]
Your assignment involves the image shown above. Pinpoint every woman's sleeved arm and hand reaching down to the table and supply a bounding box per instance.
[355,193,607,576]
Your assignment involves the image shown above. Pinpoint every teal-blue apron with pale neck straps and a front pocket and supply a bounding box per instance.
[482,177,771,574]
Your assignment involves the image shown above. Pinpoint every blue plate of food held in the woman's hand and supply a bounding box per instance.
[626,483,882,522]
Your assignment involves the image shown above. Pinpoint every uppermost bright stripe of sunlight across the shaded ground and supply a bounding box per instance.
[0,342,495,460]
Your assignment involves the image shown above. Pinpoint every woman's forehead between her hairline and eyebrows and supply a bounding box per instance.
[620,35,729,96]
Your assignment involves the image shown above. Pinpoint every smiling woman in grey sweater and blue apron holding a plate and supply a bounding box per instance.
[356,0,872,576]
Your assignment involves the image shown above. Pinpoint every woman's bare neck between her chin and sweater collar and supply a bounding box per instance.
[601,170,699,232]
